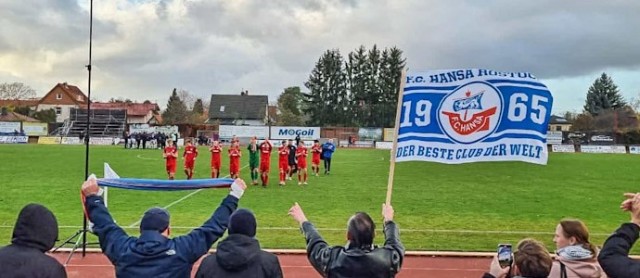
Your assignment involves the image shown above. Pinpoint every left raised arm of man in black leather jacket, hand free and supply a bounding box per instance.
[289,203,333,277]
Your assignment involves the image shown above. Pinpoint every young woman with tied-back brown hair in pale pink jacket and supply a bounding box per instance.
[549,219,607,278]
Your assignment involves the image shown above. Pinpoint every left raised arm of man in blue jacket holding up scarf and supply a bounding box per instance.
[82,178,135,264]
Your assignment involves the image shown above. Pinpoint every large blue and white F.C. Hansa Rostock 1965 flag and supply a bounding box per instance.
[396,69,553,164]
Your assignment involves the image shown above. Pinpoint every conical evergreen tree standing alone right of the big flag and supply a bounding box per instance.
[584,73,626,116]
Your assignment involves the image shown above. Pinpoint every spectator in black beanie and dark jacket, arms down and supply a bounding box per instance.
[196,209,282,278]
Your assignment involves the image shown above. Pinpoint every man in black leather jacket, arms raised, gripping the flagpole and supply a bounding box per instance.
[289,203,404,277]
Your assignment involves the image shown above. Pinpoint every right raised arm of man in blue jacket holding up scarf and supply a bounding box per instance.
[175,179,247,263]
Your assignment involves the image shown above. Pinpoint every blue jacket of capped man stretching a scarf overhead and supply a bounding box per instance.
[86,195,238,277]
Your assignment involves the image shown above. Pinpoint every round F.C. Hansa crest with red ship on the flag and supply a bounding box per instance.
[438,82,503,144]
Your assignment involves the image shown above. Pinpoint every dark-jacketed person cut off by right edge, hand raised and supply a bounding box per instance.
[598,193,640,278]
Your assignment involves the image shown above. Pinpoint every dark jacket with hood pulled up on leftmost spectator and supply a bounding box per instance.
[0,204,67,278]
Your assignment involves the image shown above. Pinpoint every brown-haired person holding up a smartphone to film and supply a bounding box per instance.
[482,238,553,278]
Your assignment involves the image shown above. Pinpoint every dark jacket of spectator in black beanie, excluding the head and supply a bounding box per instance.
[196,234,282,278]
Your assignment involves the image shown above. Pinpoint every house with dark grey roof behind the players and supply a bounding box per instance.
[207,92,269,126]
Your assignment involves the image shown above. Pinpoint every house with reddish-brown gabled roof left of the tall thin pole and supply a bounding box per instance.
[36,82,87,123]
